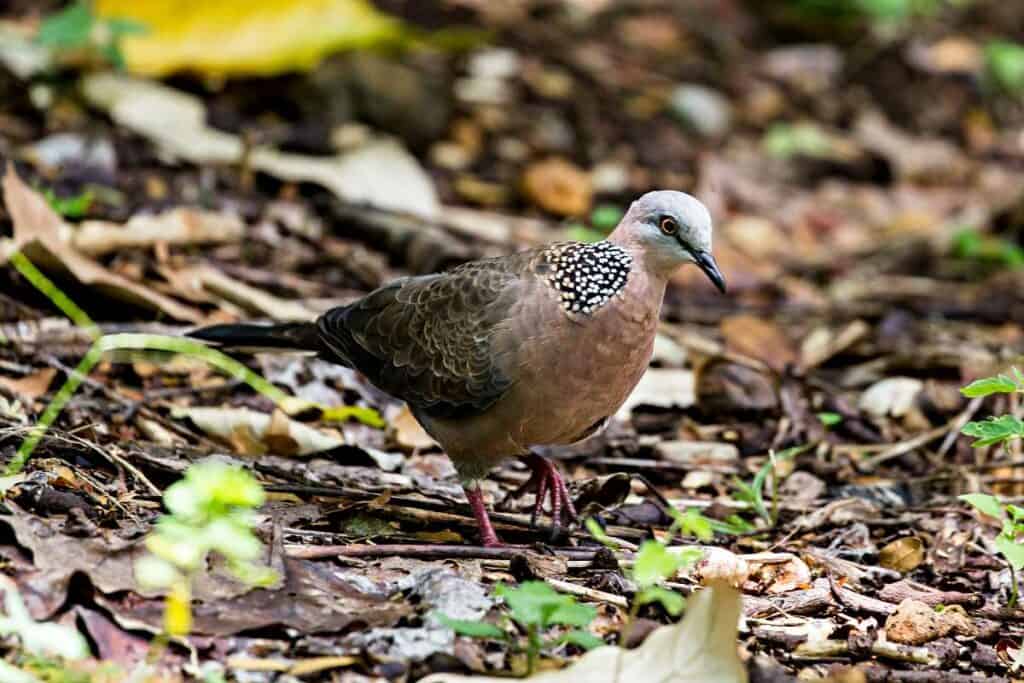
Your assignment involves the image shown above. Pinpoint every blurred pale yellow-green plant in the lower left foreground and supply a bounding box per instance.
[135,461,278,635]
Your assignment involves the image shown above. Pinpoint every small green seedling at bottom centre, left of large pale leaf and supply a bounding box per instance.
[435,581,604,676]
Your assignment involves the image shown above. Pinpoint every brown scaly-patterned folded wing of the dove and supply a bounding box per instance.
[316,252,540,417]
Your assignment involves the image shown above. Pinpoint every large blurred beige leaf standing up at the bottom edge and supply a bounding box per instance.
[422,581,748,683]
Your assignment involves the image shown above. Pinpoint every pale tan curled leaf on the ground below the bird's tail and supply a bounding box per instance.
[171,408,345,456]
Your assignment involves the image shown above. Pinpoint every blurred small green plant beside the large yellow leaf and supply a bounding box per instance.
[36,0,146,69]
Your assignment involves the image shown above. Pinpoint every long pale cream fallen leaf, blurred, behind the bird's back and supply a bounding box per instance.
[82,74,440,219]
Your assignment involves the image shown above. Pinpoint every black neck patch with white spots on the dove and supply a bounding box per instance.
[544,242,633,315]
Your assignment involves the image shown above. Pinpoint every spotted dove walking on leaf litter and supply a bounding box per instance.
[188,190,726,547]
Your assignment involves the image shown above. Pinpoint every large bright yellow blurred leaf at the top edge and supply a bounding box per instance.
[95,0,404,77]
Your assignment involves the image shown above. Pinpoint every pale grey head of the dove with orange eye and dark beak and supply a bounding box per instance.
[610,189,725,292]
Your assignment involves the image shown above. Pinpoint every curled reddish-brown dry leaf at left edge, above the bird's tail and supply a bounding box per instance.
[0,165,204,323]
